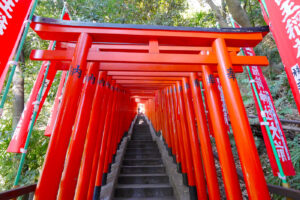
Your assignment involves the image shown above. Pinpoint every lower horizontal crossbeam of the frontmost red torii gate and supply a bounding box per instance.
[30,50,269,67]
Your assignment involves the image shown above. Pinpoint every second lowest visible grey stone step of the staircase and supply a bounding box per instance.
[118,174,169,184]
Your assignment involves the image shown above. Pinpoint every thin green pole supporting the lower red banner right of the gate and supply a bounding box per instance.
[230,16,289,188]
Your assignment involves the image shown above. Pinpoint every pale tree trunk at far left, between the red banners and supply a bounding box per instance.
[12,52,24,129]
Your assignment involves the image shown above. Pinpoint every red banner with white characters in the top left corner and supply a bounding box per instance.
[0,0,33,89]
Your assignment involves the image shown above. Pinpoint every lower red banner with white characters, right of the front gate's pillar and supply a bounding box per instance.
[243,48,295,176]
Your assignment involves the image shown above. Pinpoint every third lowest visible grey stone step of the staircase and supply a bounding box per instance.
[120,165,166,174]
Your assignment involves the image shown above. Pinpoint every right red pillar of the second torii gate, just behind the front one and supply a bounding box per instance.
[202,65,242,200]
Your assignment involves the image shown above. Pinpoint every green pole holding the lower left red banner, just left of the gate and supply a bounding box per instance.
[14,1,66,187]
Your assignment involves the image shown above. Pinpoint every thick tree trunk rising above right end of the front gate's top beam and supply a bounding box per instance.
[226,0,252,27]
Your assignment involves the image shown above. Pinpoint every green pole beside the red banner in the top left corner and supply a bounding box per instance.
[0,0,38,118]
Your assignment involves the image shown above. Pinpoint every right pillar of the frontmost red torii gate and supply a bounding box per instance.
[213,39,270,199]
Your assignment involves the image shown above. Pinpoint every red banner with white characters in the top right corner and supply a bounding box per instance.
[265,0,300,113]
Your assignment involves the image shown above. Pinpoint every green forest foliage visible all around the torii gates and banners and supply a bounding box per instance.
[0,0,300,198]
